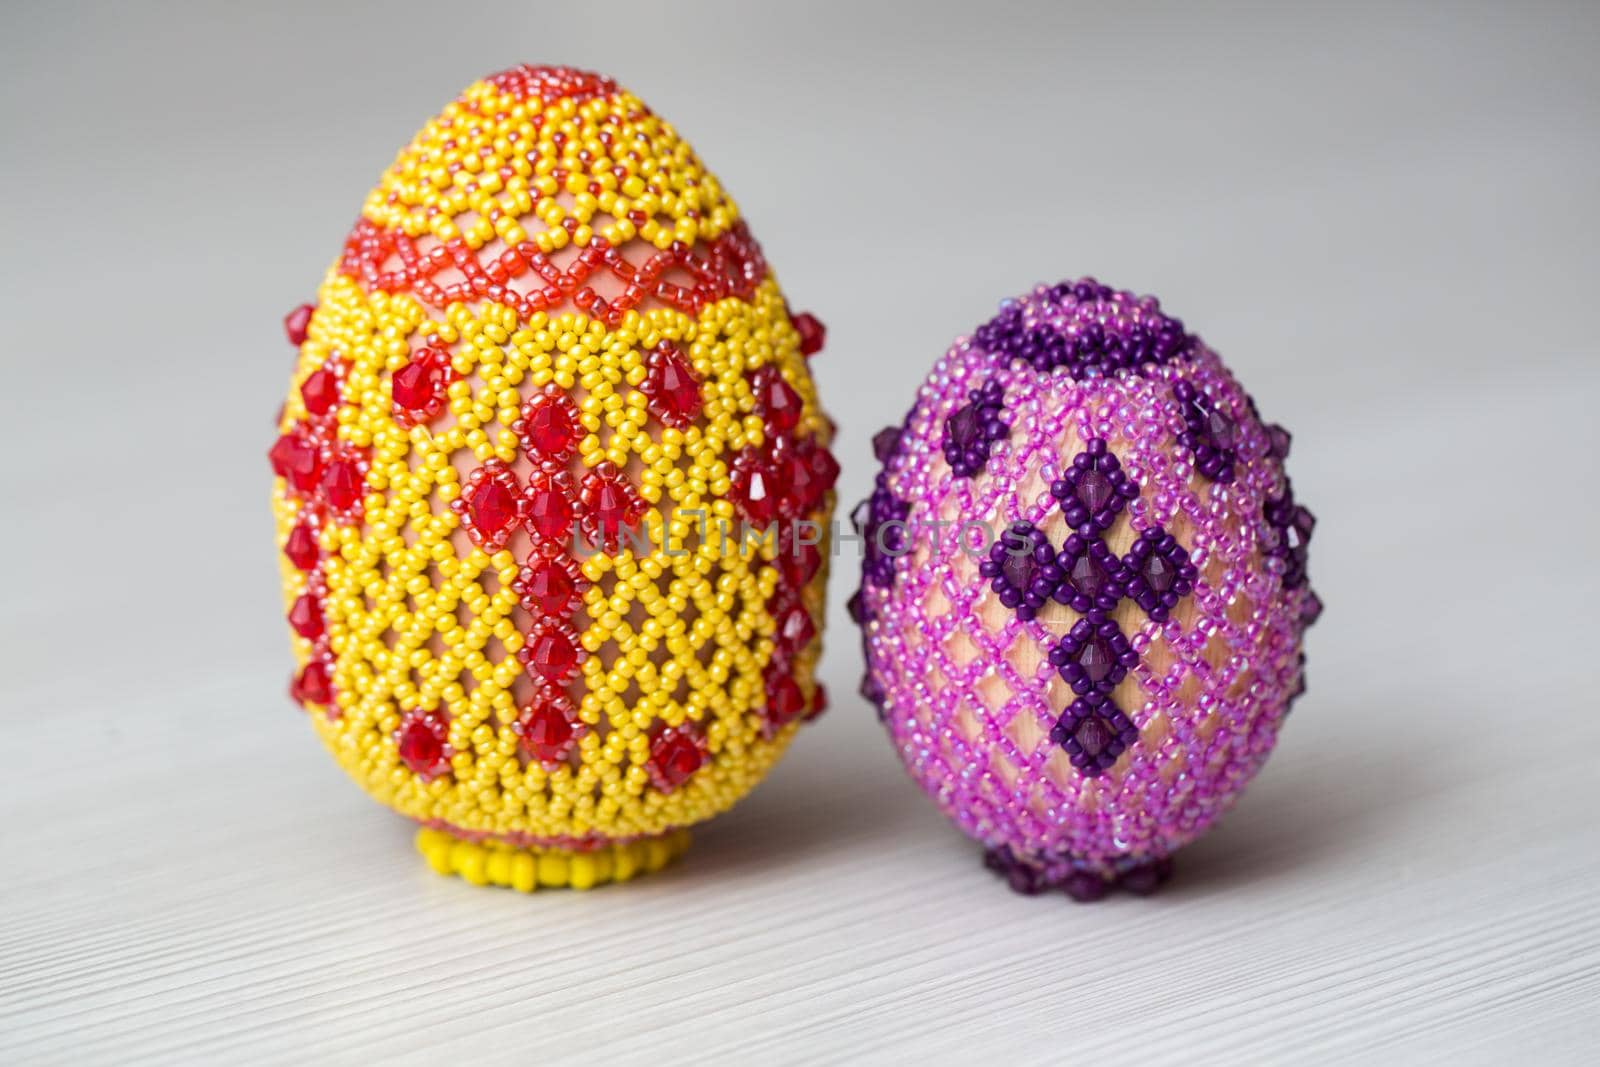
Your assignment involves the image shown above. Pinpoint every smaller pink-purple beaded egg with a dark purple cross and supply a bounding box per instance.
[850,278,1322,901]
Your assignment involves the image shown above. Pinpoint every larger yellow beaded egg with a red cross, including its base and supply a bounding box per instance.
[269,66,838,891]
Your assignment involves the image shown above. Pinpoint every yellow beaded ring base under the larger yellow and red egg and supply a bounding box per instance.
[416,829,690,893]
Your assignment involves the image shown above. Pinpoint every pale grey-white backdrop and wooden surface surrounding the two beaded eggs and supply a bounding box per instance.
[0,3,1600,1062]
